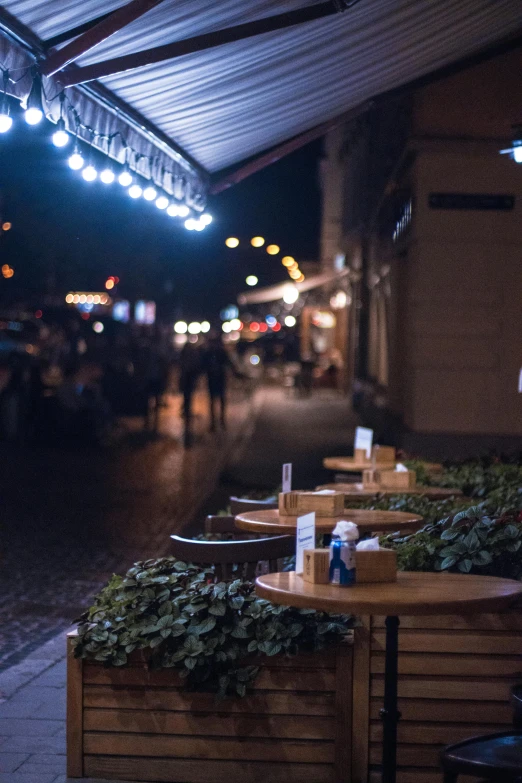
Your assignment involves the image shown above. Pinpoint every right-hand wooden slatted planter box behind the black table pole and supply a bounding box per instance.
[352,611,522,783]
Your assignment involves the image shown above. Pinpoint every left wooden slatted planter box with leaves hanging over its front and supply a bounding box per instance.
[67,639,352,783]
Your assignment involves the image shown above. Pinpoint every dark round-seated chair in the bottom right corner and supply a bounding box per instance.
[441,685,522,783]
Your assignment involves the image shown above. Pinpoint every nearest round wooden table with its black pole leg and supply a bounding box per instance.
[256,571,522,783]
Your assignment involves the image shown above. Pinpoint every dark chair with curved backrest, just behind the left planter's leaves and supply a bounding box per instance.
[171,536,295,580]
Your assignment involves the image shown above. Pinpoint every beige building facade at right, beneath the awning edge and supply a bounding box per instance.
[322,43,522,456]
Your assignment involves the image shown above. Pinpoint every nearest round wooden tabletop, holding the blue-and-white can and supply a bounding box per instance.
[256,571,522,615]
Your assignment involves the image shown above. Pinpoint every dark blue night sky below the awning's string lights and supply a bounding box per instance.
[0,104,321,319]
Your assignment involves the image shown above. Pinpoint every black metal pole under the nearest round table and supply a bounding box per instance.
[381,616,401,783]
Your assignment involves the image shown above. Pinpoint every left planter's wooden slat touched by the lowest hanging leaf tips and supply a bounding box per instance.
[83,685,335,716]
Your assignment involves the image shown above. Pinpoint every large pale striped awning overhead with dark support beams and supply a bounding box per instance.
[0,0,522,190]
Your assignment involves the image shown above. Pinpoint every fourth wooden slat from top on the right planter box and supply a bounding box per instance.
[371,675,511,702]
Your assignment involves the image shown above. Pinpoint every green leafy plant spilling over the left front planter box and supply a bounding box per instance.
[75,557,352,696]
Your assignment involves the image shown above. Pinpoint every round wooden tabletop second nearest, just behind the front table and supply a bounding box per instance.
[235,508,423,535]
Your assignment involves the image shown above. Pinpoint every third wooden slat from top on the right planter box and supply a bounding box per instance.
[371,652,522,679]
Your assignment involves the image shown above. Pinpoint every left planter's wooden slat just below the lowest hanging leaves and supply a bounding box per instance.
[83,709,334,744]
